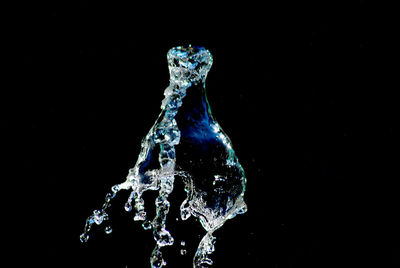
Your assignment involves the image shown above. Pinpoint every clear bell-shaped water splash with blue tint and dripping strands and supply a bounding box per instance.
[80,46,247,268]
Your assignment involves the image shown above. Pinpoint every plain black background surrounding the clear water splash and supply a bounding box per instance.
[10,1,400,268]
